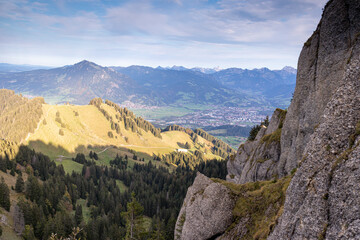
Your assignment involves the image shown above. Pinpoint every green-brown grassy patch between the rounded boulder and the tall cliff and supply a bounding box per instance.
[213,176,292,239]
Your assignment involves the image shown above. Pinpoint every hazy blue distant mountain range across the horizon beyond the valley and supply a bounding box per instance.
[0,60,296,107]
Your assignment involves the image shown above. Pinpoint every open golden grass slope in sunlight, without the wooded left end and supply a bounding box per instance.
[26,103,222,159]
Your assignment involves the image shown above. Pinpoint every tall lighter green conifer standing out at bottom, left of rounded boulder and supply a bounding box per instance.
[122,192,145,240]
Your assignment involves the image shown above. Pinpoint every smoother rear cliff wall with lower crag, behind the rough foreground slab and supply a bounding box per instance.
[228,0,360,183]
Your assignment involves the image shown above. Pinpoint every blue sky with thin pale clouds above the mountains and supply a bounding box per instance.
[0,0,327,69]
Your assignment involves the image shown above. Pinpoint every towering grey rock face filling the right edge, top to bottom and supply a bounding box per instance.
[269,0,360,236]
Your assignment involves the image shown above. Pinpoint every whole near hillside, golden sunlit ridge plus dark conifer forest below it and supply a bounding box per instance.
[0,90,234,240]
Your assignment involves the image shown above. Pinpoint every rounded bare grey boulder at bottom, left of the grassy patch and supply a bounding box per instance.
[174,173,235,240]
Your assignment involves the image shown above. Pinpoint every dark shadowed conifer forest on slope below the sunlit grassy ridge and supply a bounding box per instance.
[0,143,226,240]
